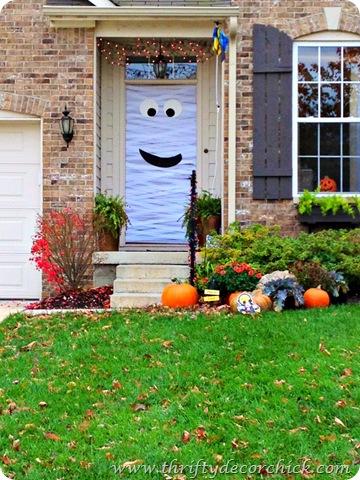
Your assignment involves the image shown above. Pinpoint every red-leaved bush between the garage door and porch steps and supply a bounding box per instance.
[30,207,97,292]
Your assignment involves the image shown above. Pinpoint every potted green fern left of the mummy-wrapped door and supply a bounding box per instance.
[94,193,130,251]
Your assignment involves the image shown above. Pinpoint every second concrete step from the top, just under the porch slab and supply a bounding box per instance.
[116,264,190,281]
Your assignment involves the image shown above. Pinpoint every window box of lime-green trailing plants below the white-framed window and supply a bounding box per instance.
[298,189,360,224]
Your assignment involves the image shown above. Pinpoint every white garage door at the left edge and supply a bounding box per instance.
[0,120,41,299]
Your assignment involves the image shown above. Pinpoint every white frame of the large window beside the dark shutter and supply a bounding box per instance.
[292,39,360,202]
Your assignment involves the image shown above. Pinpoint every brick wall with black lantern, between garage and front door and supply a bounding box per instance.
[0,0,94,296]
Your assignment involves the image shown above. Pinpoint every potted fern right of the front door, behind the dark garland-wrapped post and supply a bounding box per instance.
[183,190,221,247]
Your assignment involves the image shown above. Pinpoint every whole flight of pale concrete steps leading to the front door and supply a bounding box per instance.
[110,251,193,308]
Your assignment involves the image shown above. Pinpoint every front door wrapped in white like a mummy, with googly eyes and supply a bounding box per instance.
[125,85,197,244]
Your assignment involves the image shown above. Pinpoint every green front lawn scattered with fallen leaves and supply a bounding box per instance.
[0,305,360,480]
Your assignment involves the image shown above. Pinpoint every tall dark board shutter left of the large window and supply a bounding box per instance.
[253,25,292,200]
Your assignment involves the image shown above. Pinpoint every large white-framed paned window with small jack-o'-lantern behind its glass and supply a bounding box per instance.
[294,42,360,194]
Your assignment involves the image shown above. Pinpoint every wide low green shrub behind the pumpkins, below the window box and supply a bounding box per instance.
[197,224,360,291]
